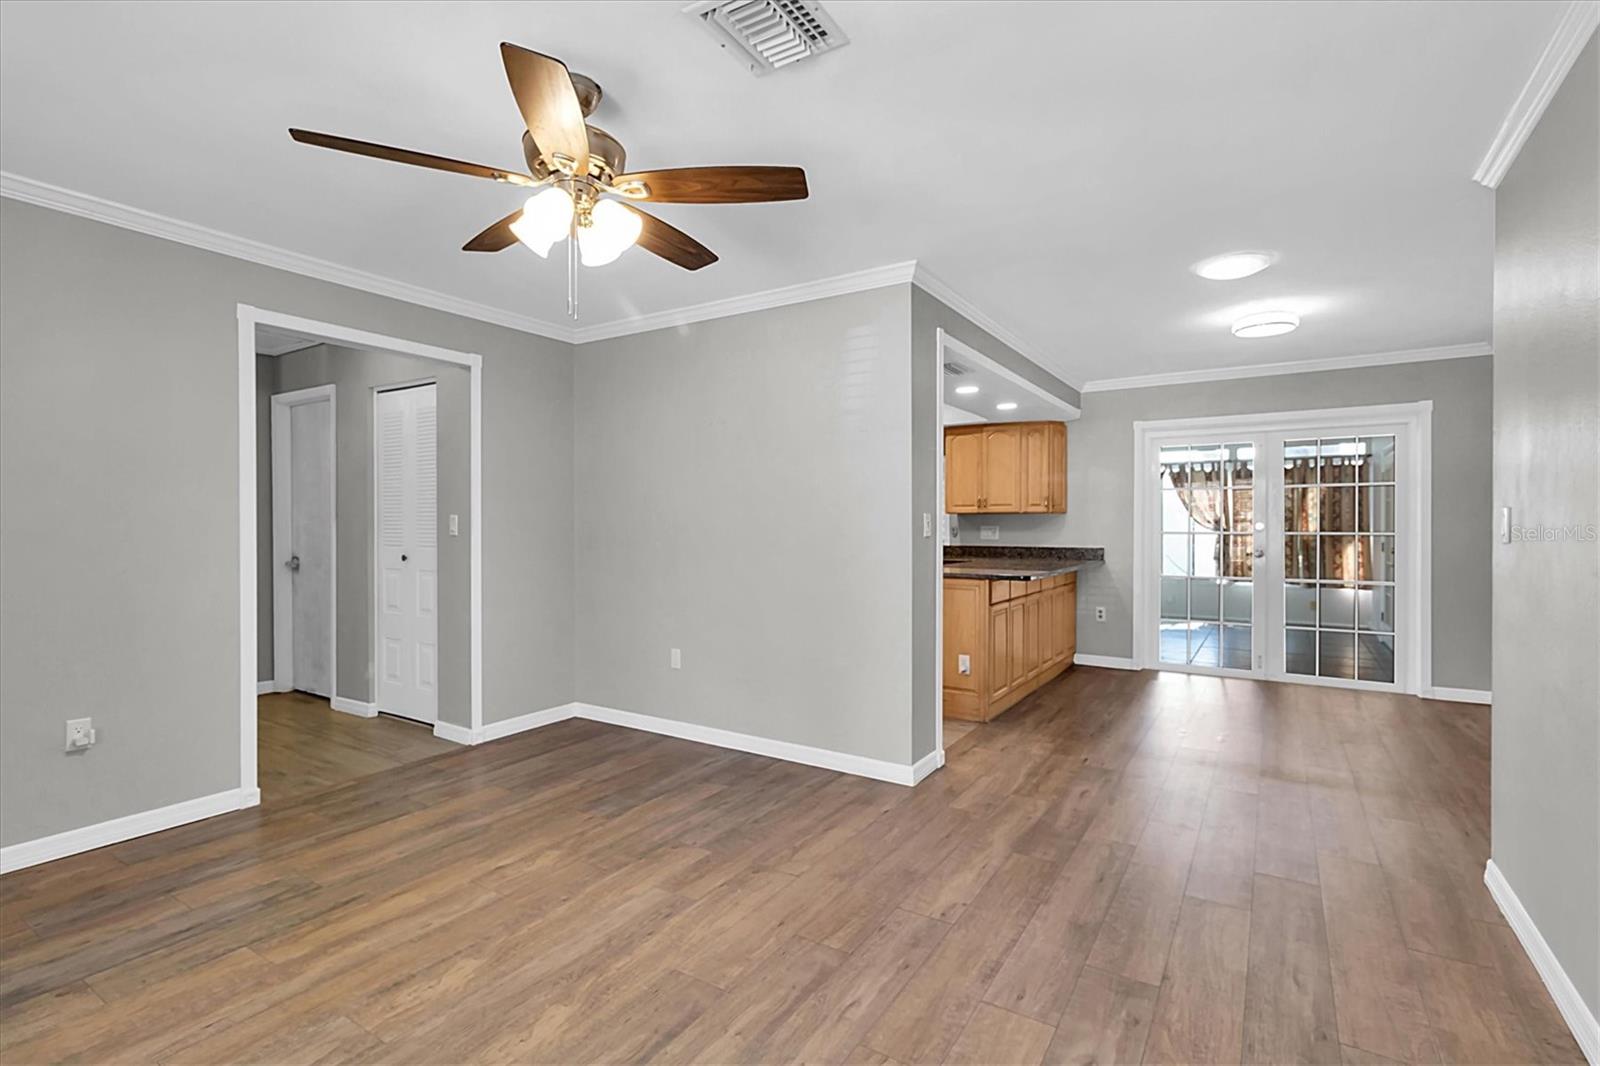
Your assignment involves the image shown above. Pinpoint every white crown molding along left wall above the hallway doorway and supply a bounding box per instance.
[0,171,573,343]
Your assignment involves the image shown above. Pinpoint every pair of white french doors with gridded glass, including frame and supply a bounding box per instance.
[1134,405,1430,691]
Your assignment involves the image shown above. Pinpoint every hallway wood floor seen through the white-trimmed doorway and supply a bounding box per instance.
[256,691,458,807]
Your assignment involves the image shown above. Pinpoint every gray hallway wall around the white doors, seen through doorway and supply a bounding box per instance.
[256,344,472,725]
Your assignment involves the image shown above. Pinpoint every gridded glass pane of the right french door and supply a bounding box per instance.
[1282,434,1397,683]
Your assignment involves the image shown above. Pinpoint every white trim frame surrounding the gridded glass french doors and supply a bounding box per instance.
[1131,400,1434,695]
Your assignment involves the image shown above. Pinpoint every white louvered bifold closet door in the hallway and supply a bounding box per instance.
[373,384,438,722]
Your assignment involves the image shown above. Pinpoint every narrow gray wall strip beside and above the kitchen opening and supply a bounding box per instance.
[910,287,1080,759]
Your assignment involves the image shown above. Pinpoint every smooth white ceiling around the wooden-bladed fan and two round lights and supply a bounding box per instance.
[0,0,1563,383]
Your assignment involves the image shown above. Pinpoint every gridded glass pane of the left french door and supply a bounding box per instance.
[1158,442,1256,671]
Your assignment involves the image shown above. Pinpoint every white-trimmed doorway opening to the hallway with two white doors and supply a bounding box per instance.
[238,306,482,802]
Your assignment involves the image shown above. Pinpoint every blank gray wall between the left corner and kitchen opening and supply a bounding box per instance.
[574,287,931,763]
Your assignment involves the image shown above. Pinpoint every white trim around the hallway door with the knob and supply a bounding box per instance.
[270,384,339,698]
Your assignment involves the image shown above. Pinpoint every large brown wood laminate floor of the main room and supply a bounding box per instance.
[0,667,1579,1063]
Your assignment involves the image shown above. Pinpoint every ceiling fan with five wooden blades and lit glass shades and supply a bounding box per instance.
[290,43,808,319]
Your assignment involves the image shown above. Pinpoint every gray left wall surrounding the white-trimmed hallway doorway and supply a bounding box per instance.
[0,198,574,844]
